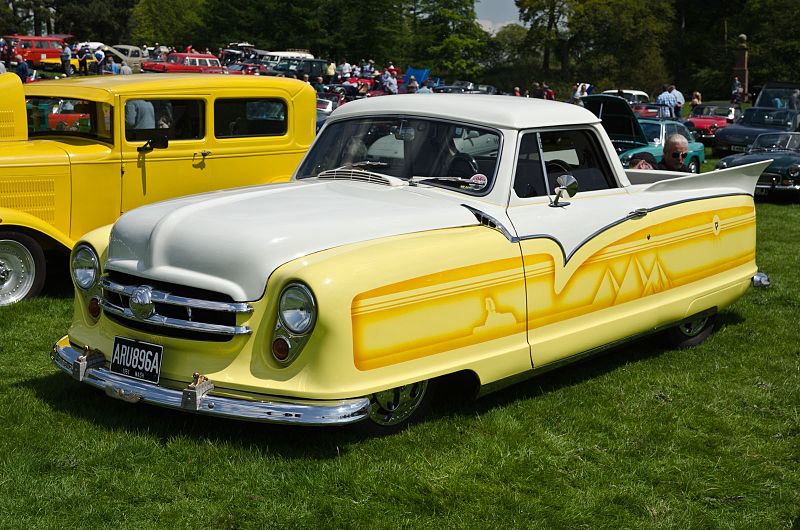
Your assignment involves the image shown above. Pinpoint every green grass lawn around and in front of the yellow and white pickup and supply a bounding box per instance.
[0,200,800,529]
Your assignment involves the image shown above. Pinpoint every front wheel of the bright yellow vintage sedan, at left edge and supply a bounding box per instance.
[0,232,46,306]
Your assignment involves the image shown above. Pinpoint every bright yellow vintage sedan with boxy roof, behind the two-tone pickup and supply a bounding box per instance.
[0,73,315,305]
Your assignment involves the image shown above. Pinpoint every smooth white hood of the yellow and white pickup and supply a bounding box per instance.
[106,179,477,301]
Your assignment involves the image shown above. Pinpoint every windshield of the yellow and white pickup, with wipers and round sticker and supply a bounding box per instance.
[297,117,500,195]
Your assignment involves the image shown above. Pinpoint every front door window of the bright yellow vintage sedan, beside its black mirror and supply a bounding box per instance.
[125,99,205,142]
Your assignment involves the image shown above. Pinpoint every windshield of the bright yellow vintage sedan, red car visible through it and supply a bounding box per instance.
[25,96,114,143]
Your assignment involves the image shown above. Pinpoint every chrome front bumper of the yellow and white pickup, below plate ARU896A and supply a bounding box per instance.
[50,337,370,425]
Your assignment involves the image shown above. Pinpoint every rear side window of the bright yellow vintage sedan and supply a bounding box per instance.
[214,98,288,138]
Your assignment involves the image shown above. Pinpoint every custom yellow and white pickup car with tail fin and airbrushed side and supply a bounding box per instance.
[51,95,768,429]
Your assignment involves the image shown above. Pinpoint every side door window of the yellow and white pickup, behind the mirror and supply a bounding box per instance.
[540,130,617,191]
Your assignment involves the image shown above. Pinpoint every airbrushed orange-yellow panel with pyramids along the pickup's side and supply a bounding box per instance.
[351,197,755,370]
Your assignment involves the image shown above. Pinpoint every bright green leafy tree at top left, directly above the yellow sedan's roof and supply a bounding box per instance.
[131,0,205,46]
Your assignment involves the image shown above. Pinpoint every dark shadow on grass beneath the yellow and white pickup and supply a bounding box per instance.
[15,311,744,452]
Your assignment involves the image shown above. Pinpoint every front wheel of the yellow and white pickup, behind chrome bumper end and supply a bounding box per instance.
[354,381,435,435]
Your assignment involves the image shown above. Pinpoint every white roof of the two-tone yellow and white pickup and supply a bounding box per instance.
[330,94,600,129]
